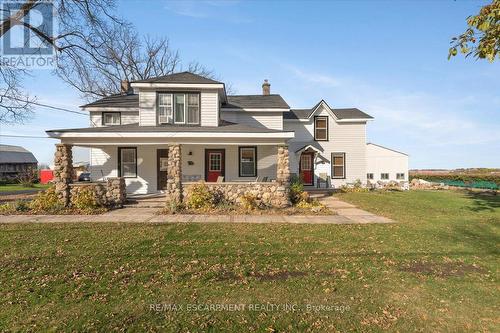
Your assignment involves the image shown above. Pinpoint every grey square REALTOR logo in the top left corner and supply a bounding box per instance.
[0,0,56,69]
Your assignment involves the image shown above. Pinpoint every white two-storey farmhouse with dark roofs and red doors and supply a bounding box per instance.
[47,72,408,194]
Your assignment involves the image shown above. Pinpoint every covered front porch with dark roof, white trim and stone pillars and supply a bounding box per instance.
[47,124,293,206]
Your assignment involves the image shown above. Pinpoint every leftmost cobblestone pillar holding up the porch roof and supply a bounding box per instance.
[54,143,74,206]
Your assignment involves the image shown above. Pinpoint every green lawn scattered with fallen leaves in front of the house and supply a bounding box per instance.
[0,191,500,332]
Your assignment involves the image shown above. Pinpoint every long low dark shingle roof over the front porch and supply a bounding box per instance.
[46,121,290,133]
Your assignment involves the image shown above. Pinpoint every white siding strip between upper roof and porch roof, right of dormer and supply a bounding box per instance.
[221,111,283,130]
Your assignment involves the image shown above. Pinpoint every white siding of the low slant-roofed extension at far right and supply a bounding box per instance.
[366,143,408,182]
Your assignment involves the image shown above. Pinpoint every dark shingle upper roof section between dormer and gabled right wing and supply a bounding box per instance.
[222,94,290,109]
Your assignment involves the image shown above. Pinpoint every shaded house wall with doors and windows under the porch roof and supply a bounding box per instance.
[90,142,288,194]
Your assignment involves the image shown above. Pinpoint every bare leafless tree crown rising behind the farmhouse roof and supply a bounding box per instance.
[57,24,218,100]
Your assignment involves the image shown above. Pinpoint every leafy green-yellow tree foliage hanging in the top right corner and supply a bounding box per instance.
[448,0,500,62]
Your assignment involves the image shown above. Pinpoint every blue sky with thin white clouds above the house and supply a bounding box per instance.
[0,0,500,168]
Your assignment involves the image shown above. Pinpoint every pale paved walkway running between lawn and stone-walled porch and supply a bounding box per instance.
[0,197,394,224]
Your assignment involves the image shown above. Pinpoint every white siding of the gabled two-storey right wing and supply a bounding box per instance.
[284,104,366,187]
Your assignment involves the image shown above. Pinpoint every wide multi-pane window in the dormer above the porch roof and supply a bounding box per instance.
[158,93,200,125]
